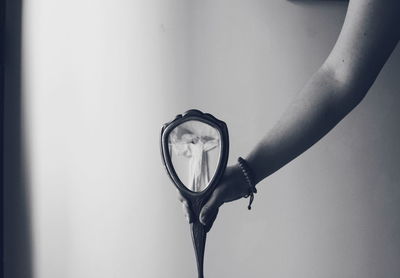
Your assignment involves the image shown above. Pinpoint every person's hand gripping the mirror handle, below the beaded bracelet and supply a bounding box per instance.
[178,165,249,231]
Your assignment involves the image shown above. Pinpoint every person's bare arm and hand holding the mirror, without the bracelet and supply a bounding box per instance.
[179,0,400,229]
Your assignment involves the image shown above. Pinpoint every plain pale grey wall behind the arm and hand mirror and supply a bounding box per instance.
[5,0,400,278]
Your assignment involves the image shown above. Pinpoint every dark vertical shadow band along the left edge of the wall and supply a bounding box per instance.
[3,0,33,278]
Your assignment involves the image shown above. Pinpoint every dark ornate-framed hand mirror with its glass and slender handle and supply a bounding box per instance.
[161,110,229,278]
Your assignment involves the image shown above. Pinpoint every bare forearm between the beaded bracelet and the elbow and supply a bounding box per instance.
[246,69,368,183]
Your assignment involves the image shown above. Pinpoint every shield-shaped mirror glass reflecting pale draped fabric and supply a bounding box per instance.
[168,120,221,192]
